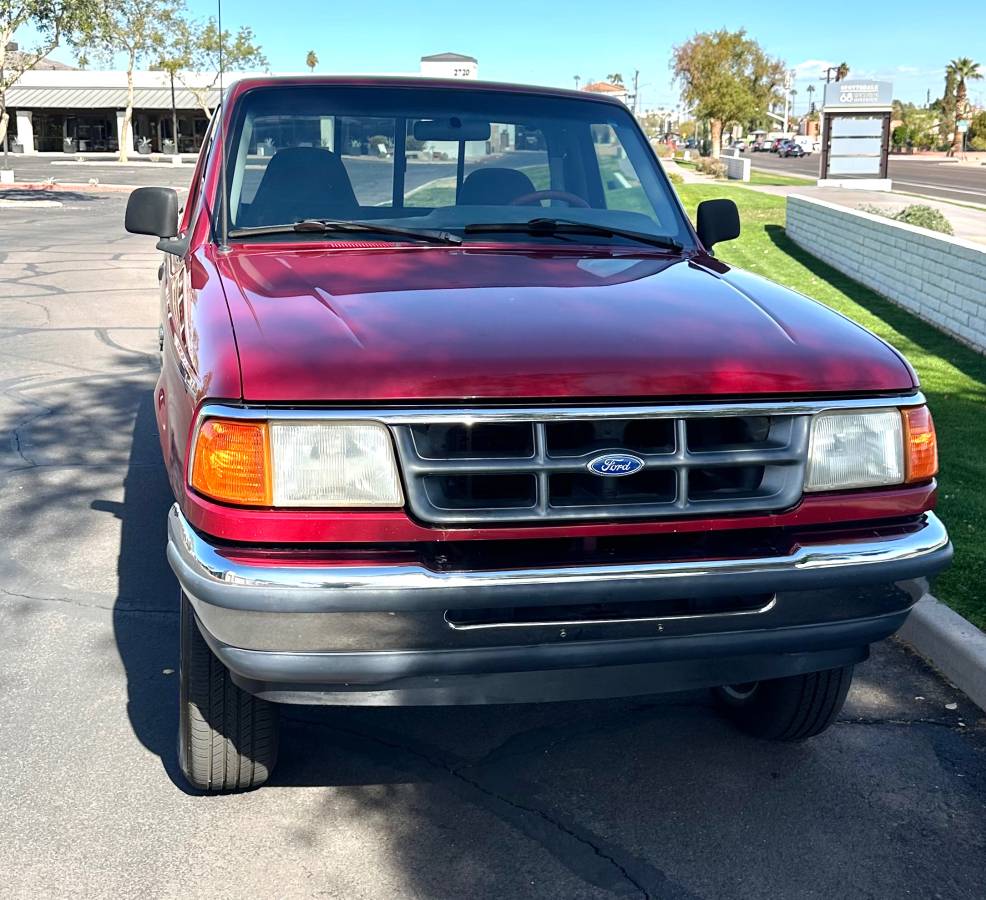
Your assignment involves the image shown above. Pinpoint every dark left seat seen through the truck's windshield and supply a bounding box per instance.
[244,147,359,225]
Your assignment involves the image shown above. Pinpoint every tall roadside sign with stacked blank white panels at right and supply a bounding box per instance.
[819,80,893,191]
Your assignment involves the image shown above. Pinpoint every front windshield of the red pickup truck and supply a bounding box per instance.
[227,84,692,247]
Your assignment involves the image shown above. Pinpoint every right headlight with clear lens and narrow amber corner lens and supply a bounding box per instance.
[805,406,938,491]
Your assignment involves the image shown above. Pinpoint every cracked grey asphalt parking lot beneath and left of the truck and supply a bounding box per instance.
[0,193,986,900]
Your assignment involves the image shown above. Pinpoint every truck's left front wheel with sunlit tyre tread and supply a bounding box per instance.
[178,593,278,791]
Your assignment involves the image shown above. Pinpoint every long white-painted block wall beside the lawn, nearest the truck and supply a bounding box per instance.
[787,194,986,353]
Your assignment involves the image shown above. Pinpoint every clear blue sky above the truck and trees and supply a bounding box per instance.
[28,0,986,111]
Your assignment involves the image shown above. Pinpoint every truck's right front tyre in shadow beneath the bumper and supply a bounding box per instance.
[712,666,853,741]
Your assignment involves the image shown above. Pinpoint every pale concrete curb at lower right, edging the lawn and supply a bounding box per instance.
[897,594,986,710]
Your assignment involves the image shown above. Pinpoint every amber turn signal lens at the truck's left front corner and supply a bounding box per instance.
[191,419,272,506]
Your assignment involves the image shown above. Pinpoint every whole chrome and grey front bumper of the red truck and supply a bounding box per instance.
[168,507,952,694]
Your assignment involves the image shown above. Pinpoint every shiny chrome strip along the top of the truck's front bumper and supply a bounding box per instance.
[168,505,948,600]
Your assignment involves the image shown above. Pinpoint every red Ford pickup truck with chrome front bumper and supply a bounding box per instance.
[126,78,952,791]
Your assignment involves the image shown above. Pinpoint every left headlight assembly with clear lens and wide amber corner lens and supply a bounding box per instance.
[189,419,404,508]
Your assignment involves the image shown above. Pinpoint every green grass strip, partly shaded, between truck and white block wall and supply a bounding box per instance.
[678,184,986,628]
